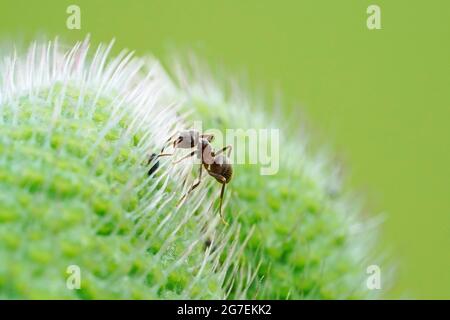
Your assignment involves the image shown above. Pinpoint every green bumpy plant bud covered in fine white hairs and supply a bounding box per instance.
[0,40,380,299]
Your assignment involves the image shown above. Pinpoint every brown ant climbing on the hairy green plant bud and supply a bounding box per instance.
[157,130,233,225]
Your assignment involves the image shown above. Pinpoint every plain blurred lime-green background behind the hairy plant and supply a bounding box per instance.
[0,0,450,298]
